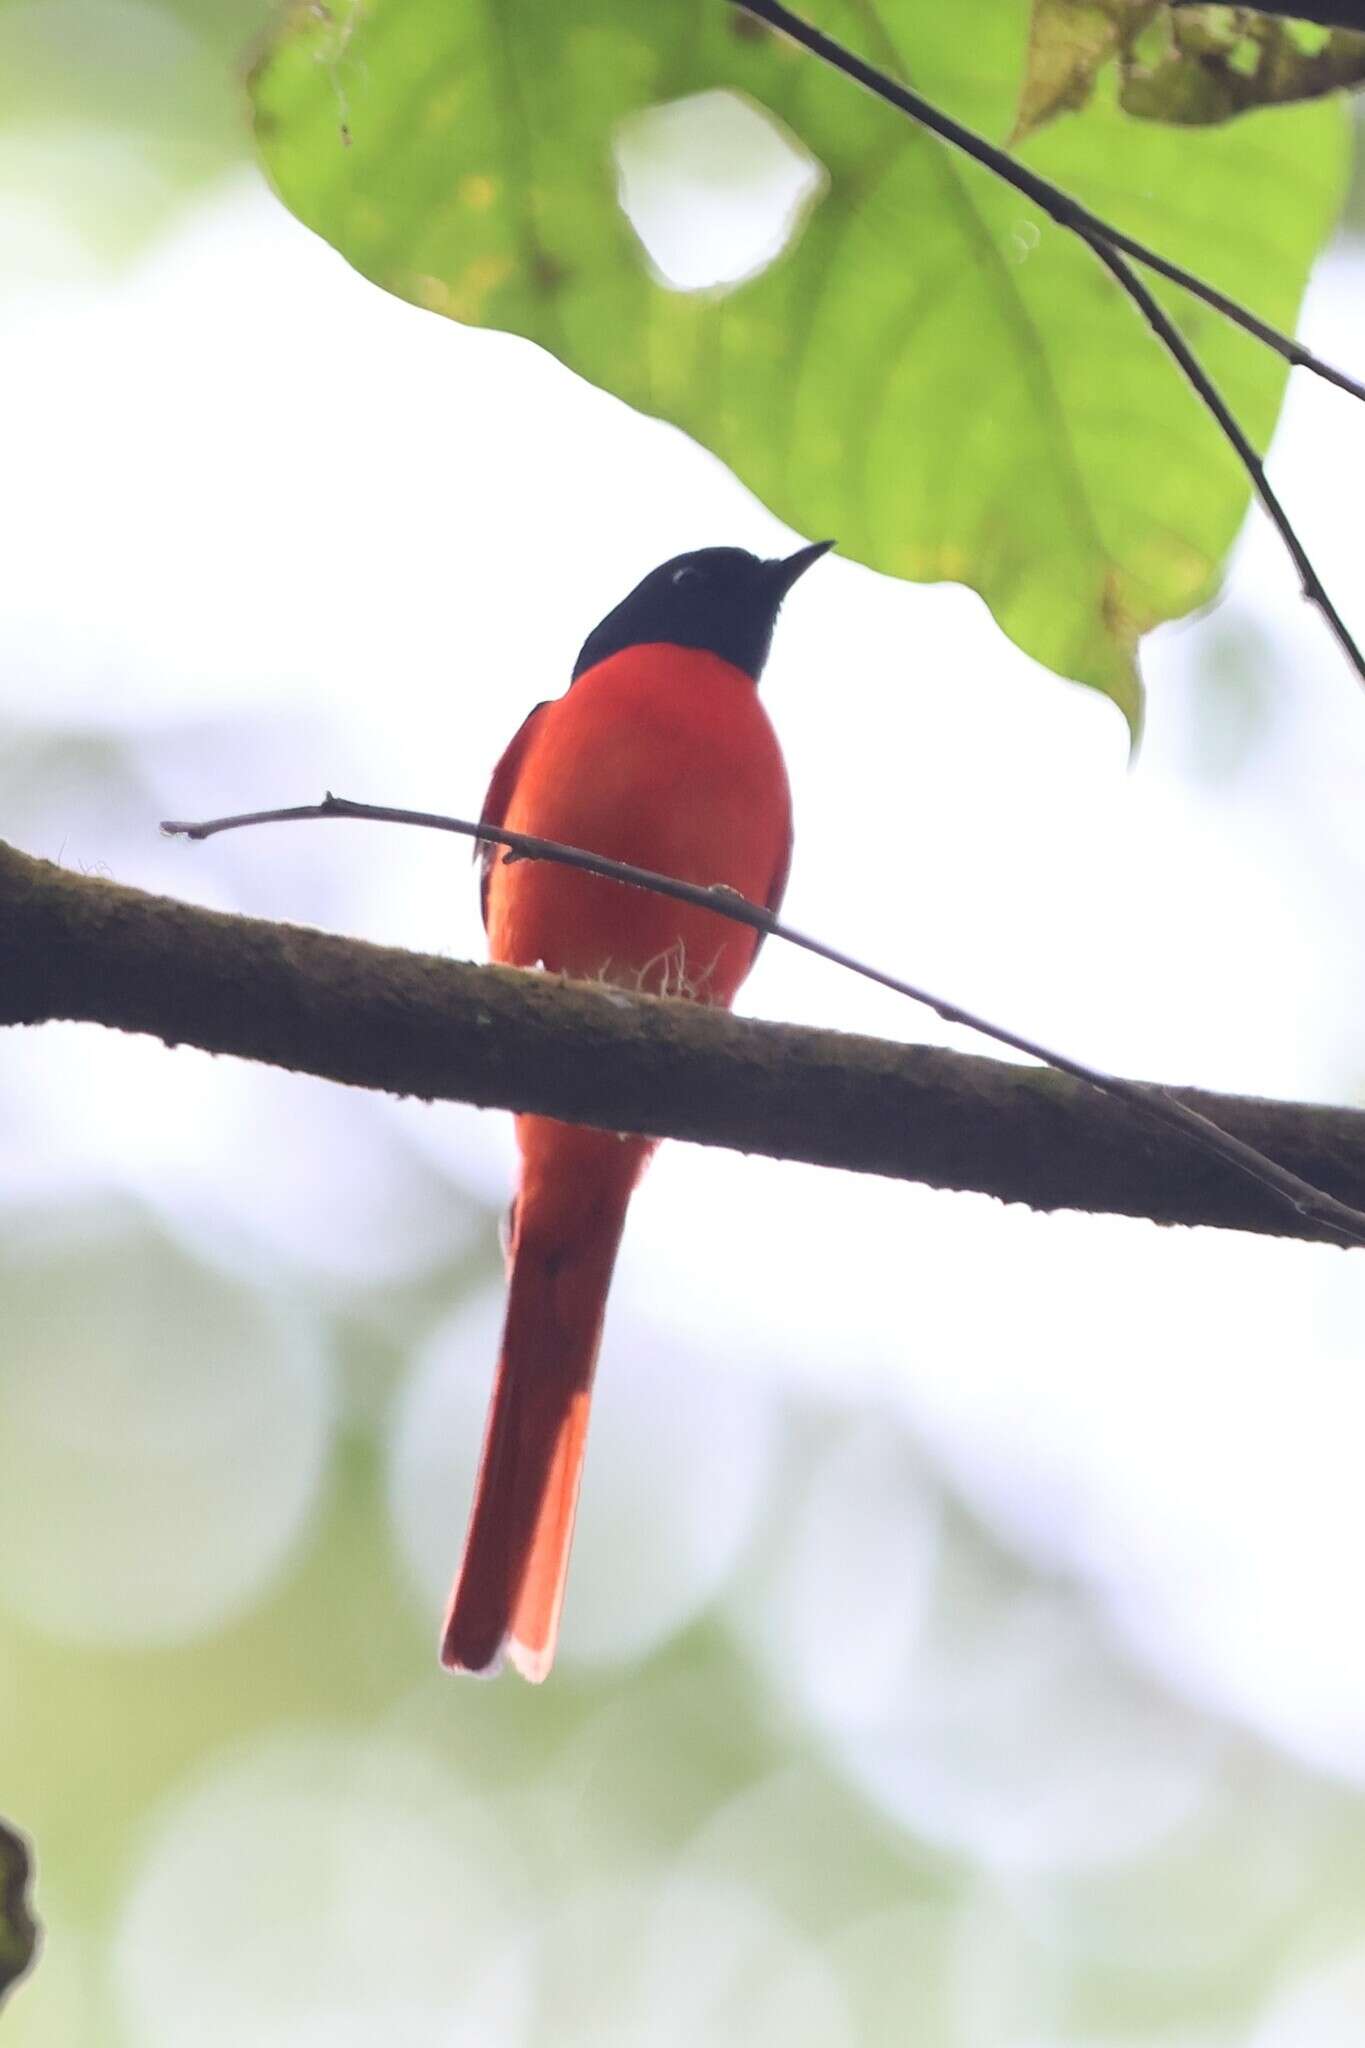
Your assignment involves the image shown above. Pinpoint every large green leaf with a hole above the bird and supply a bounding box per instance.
[254,0,1345,729]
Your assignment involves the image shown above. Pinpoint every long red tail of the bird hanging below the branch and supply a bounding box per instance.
[440,1118,645,1683]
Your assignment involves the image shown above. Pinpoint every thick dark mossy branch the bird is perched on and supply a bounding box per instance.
[0,844,1365,1243]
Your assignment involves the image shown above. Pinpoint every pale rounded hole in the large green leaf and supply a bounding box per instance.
[612,92,829,291]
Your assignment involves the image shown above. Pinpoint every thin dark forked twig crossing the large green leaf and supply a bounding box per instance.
[731,0,1365,682]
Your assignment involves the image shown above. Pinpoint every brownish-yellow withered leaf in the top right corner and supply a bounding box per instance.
[1015,0,1365,141]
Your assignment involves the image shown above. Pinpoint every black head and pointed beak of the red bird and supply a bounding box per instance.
[573,541,835,680]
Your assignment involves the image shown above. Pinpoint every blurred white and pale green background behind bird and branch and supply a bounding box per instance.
[0,0,1365,2048]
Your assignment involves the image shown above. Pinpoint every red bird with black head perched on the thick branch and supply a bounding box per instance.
[442,541,835,1683]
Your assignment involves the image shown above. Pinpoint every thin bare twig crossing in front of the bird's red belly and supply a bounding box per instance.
[162,791,1365,1245]
